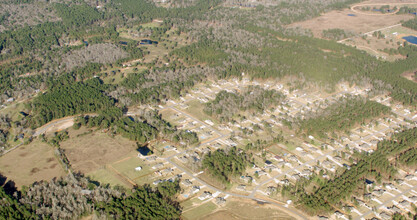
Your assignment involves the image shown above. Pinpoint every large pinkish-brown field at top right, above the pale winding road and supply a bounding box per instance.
[290,1,417,37]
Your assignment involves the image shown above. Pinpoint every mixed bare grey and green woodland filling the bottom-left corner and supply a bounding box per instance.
[0,175,182,219]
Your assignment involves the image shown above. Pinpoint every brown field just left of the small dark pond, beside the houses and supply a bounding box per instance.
[61,127,136,173]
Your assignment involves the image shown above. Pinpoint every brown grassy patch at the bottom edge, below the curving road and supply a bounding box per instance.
[200,199,295,220]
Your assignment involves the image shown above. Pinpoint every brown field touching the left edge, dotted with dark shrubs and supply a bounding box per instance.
[0,140,66,188]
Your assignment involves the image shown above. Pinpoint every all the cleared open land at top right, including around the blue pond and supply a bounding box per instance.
[289,0,417,61]
